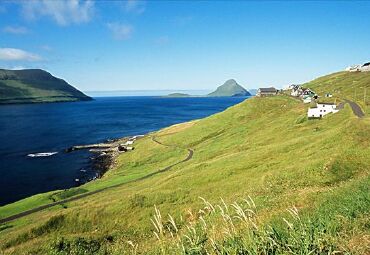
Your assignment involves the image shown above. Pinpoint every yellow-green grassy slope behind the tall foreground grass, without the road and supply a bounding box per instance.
[0,70,370,254]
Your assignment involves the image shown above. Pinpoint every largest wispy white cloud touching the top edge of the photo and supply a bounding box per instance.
[22,0,94,26]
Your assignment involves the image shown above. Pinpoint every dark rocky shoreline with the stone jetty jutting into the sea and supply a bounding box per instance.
[65,135,144,181]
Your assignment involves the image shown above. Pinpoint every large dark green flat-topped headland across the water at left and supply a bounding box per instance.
[0,69,92,104]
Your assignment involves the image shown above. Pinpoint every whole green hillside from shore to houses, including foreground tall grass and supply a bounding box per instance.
[0,70,370,254]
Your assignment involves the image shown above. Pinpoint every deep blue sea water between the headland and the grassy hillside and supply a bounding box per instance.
[0,97,246,205]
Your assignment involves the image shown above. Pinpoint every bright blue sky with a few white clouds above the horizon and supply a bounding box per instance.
[0,0,370,91]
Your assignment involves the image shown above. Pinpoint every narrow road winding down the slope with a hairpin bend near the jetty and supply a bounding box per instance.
[0,136,194,224]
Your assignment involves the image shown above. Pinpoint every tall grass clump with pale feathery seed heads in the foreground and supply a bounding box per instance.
[151,197,346,255]
